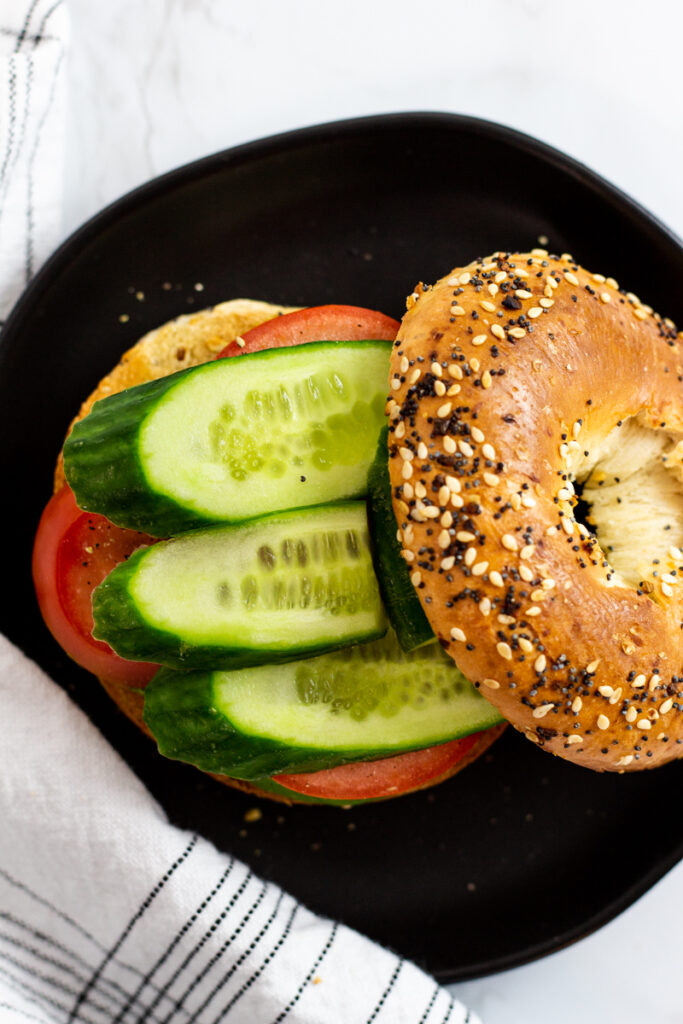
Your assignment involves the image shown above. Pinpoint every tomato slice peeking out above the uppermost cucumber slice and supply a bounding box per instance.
[218,306,400,359]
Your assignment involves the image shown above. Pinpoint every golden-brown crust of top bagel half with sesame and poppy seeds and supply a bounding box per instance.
[388,250,683,771]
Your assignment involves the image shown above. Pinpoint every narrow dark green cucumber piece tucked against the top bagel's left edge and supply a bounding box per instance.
[368,426,434,650]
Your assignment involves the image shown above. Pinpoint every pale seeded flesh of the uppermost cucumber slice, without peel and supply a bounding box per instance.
[138,341,391,520]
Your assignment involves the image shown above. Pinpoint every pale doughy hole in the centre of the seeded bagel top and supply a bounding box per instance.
[570,418,683,600]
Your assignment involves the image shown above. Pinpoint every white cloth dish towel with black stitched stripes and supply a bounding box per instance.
[0,0,476,1024]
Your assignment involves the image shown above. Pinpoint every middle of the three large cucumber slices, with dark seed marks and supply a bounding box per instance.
[93,502,386,669]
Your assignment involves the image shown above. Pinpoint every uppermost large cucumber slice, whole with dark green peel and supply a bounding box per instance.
[65,341,391,537]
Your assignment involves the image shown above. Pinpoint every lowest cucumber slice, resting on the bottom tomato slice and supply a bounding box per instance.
[144,633,502,779]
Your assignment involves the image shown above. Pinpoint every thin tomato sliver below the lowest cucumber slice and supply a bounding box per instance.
[273,732,481,801]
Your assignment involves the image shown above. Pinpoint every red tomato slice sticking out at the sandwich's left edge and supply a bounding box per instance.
[33,486,158,686]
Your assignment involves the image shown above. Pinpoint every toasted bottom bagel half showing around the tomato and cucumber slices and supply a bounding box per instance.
[60,299,505,804]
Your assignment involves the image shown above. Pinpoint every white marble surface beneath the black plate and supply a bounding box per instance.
[60,0,683,1024]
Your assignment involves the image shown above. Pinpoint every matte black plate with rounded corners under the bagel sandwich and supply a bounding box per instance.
[5,114,683,980]
